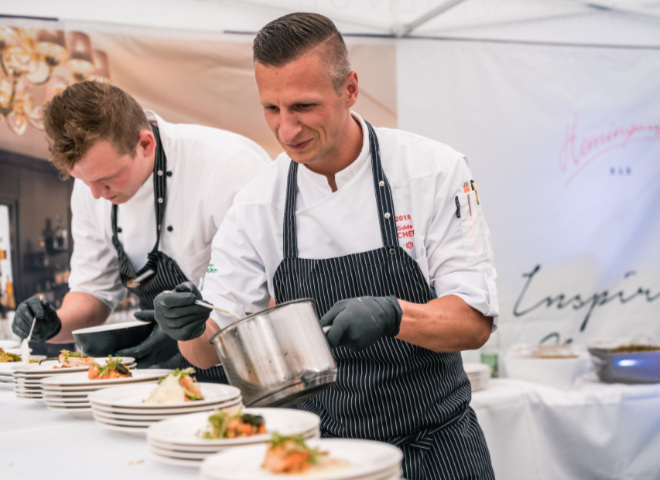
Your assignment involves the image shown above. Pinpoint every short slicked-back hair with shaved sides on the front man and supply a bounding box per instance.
[252,13,351,95]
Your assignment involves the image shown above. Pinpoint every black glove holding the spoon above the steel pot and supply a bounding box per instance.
[154,282,210,340]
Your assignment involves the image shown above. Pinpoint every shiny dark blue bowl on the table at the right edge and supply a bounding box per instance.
[589,347,660,383]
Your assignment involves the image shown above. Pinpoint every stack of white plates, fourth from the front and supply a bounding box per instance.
[41,369,170,413]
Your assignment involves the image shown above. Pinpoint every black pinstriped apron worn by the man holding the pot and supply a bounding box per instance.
[273,124,494,480]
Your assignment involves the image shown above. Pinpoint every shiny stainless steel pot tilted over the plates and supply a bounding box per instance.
[211,299,337,407]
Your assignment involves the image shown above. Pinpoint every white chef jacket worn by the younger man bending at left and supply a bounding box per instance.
[69,111,272,309]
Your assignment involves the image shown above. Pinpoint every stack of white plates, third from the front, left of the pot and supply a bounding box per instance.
[89,383,242,434]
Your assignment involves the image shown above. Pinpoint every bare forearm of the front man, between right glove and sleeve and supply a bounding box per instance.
[396,295,493,352]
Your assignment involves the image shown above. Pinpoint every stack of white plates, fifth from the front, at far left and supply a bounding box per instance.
[12,357,135,401]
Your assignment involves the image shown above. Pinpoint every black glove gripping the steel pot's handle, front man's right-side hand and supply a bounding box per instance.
[321,297,402,350]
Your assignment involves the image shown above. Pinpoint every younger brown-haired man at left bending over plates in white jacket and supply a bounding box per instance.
[13,82,271,379]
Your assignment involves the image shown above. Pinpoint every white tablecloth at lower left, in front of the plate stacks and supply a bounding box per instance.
[0,385,200,480]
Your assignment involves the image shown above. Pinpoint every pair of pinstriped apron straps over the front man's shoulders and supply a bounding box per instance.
[282,121,399,258]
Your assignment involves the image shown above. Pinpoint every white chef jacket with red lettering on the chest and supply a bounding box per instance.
[202,113,499,328]
